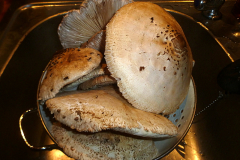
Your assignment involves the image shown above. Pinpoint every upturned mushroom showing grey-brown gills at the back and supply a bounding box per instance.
[58,0,133,48]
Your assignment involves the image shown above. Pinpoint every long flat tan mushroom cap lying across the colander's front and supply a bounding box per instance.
[46,86,177,138]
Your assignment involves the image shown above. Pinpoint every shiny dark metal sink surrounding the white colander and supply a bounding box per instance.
[0,1,240,160]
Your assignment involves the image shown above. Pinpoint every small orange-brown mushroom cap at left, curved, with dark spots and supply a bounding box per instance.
[38,48,103,101]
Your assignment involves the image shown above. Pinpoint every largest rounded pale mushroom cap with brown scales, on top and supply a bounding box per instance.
[104,2,193,114]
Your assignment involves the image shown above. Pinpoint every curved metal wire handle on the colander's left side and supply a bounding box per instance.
[19,108,58,150]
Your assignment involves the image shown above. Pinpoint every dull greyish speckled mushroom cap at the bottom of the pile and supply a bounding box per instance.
[51,124,158,160]
